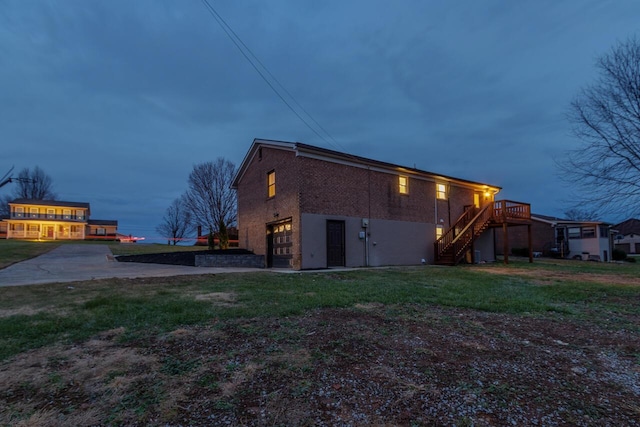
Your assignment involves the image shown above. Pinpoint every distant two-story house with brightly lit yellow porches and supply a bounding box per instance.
[2,199,118,240]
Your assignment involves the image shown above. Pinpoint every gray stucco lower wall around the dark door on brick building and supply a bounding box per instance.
[301,214,435,269]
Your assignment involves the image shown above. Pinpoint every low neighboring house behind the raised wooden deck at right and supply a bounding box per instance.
[496,214,615,262]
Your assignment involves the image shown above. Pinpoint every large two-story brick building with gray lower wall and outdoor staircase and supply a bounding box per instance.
[233,139,530,269]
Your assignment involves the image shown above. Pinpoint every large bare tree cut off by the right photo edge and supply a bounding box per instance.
[558,37,640,216]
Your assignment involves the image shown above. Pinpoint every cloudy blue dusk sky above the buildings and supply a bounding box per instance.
[0,0,640,241]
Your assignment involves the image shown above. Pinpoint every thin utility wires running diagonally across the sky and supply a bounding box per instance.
[201,0,344,151]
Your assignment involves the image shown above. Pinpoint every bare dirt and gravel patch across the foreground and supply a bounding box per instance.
[0,304,640,426]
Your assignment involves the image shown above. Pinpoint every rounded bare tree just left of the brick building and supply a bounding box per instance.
[186,157,237,249]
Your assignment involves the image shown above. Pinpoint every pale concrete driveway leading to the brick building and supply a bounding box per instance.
[0,244,260,286]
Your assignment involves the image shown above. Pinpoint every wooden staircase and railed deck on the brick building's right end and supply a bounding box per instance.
[434,200,531,265]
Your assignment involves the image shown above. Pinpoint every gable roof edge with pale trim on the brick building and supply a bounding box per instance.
[231,138,502,192]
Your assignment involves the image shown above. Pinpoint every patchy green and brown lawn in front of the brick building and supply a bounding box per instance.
[0,245,640,426]
